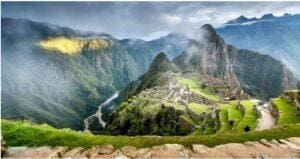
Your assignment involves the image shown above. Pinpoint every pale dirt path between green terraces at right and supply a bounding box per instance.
[256,103,275,130]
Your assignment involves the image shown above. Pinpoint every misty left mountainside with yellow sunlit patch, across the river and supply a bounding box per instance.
[1,18,184,129]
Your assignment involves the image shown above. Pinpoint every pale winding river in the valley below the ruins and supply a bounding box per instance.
[83,92,119,131]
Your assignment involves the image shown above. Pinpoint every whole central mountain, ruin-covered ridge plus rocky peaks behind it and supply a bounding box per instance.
[104,24,299,135]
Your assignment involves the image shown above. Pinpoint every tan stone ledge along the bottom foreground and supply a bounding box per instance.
[5,137,300,158]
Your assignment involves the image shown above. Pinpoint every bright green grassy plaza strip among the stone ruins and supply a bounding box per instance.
[177,77,220,101]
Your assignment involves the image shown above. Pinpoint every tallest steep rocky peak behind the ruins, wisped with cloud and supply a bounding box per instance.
[173,24,238,88]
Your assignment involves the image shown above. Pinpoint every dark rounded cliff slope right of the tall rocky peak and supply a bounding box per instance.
[228,46,297,99]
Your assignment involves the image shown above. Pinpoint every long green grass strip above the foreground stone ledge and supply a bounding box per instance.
[1,120,300,148]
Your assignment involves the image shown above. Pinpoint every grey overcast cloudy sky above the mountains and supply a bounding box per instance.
[1,2,300,40]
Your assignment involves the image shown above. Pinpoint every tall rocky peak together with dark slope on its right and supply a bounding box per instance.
[173,25,296,99]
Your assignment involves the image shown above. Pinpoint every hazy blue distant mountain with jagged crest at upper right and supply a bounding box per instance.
[217,14,300,79]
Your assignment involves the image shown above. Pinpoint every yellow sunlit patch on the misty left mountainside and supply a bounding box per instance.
[38,37,108,55]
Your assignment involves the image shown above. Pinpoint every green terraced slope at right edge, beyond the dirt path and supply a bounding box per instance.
[272,98,300,125]
